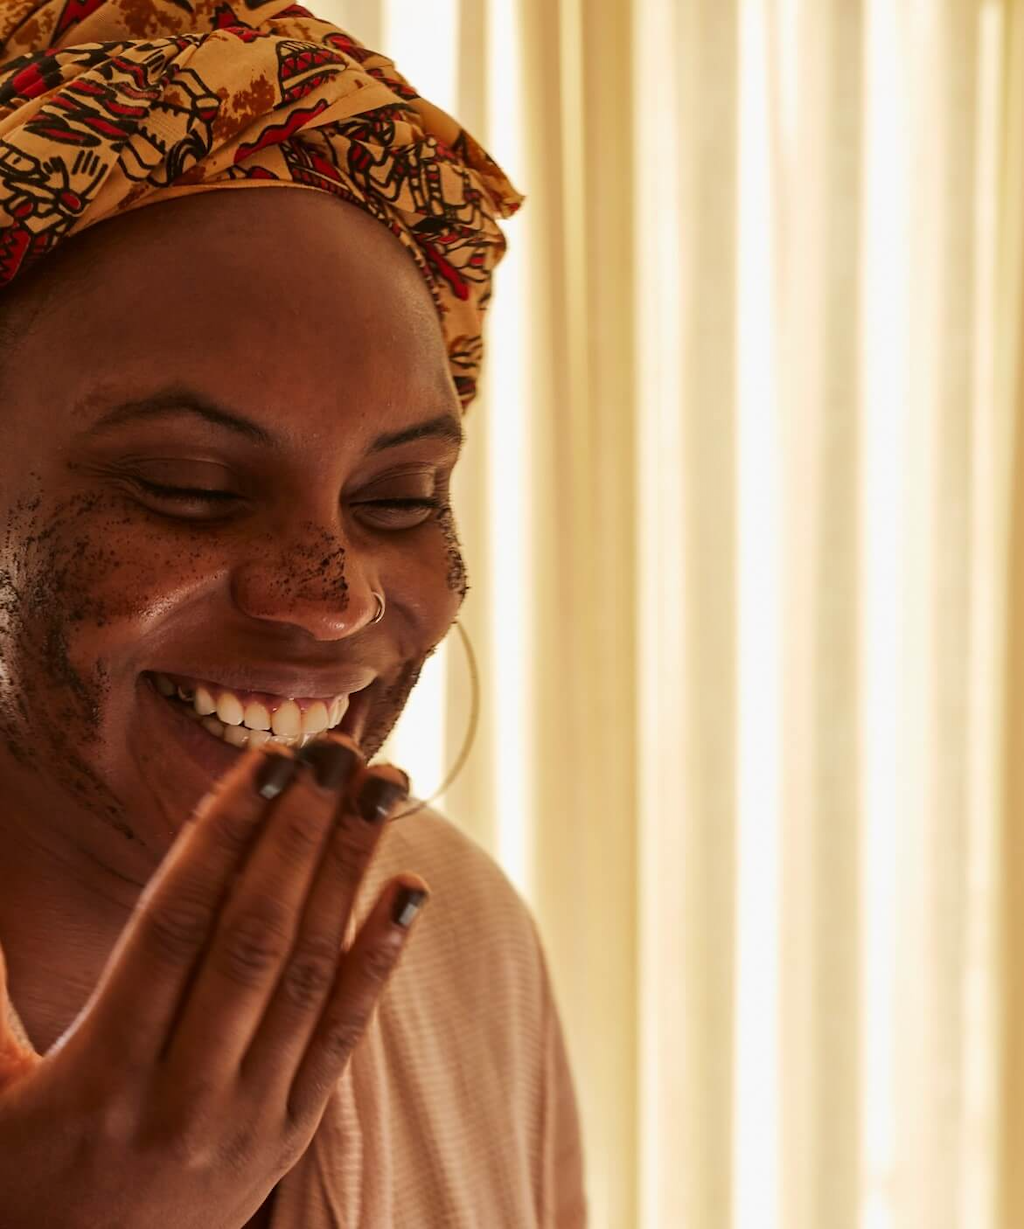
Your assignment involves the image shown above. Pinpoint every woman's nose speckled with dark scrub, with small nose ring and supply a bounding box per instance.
[231,535,382,640]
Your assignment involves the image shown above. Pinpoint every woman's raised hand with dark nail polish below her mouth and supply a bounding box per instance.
[0,736,427,1229]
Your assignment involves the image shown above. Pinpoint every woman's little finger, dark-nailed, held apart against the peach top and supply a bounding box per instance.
[288,874,429,1129]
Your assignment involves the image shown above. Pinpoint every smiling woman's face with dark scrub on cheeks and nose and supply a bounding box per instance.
[0,188,466,884]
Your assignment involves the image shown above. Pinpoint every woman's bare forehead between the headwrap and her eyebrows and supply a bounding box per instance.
[9,188,459,439]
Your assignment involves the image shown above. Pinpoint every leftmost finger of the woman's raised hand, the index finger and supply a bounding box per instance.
[74,748,291,1072]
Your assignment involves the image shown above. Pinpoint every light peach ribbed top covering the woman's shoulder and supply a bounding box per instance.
[3,810,586,1229]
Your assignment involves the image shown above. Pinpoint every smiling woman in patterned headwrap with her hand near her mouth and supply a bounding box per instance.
[0,0,585,1229]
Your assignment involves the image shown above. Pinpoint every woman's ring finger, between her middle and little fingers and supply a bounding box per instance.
[243,766,408,1094]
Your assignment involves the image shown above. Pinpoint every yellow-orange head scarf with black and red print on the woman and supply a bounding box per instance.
[0,0,522,410]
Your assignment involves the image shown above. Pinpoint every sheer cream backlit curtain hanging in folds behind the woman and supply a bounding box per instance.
[322,0,1024,1229]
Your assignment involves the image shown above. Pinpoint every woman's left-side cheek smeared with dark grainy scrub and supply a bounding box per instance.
[0,495,215,820]
